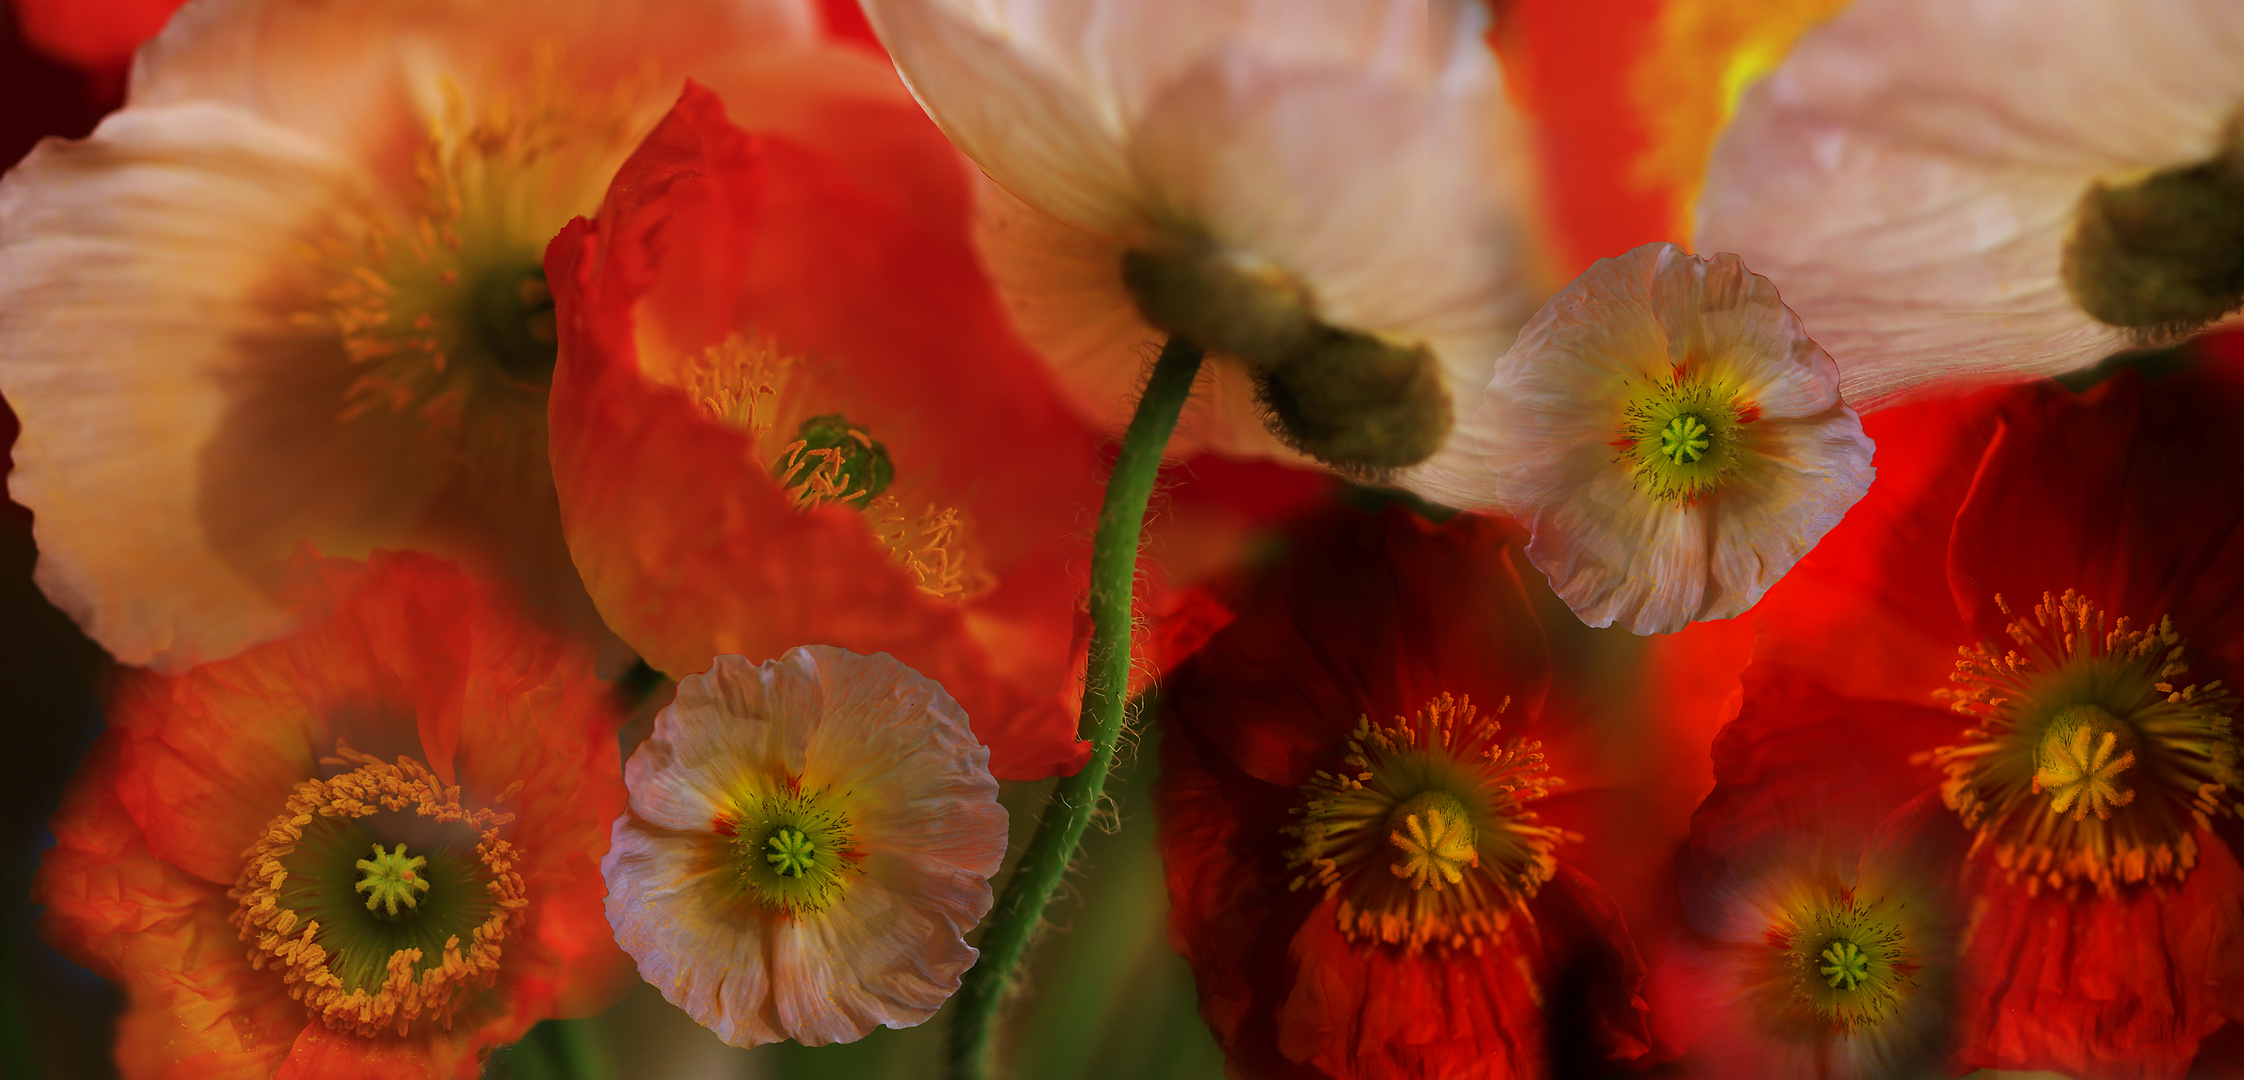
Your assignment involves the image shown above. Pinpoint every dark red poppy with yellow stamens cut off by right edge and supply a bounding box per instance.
[1746,348,2244,1078]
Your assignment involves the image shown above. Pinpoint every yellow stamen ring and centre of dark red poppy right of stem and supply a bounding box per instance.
[1286,694,1566,952]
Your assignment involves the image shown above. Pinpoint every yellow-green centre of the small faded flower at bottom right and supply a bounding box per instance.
[1777,889,1916,1031]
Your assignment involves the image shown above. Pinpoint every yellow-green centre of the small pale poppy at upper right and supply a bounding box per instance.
[1613,366,1759,503]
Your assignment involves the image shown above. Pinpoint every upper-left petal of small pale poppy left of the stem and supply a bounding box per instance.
[624,649,826,831]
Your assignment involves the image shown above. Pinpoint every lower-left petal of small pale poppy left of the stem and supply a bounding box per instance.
[599,813,788,1046]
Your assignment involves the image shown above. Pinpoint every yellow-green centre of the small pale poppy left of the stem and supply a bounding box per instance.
[716,784,862,916]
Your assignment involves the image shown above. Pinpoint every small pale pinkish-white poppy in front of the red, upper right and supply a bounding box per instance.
[1468,242,1871,633]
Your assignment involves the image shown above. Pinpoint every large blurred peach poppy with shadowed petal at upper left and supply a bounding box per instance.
[0,0,857,669]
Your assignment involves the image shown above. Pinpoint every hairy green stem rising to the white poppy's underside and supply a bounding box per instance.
[951,337,1203,1080]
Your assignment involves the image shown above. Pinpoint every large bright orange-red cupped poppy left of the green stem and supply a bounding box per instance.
[548,81,1097,779]
